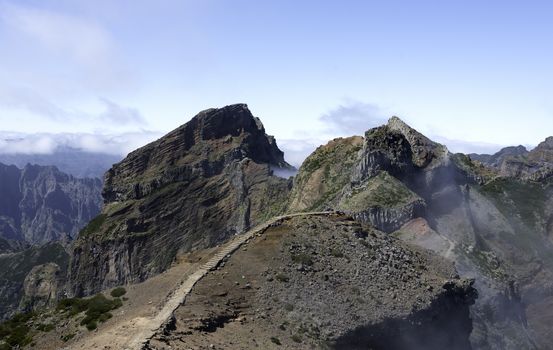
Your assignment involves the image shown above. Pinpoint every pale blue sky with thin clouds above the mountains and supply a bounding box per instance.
[0,0,553,164]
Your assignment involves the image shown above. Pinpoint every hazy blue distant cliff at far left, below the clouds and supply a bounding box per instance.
[0,164,102,244]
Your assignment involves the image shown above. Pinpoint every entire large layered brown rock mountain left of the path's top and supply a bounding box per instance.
[70,105,290,295]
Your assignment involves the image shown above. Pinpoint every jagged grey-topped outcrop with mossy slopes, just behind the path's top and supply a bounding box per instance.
[288,117,436,232]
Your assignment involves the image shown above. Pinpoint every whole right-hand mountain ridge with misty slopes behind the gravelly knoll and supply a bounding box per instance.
[288,118,553,349]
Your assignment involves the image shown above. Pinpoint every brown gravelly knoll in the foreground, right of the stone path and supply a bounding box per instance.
[147,215,476,349]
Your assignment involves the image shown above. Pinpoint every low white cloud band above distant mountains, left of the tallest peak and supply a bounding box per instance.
[0,130,163,156]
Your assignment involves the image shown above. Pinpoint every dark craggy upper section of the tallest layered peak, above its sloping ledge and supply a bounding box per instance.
[104,104,291,202]
